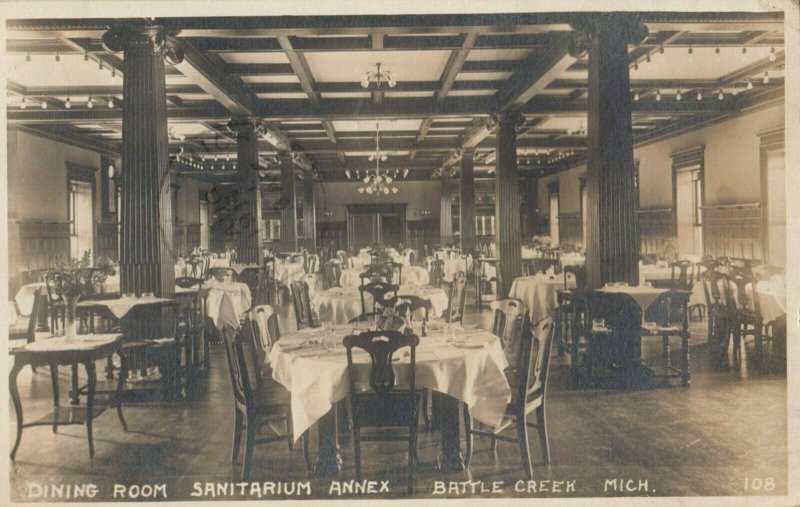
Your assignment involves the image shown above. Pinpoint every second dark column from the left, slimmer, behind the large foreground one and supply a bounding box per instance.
[228,118,261,264]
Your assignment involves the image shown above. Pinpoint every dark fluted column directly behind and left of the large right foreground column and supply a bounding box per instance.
[494,114,522,297]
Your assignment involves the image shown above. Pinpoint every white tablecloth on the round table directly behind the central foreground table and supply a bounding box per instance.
[311,286,449,324]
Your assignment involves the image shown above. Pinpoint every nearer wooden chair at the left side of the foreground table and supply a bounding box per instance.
[222,327,311,481]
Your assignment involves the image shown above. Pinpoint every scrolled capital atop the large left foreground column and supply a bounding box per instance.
[102,21,183,65]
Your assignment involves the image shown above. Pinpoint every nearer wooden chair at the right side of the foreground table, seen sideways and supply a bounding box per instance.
[464,317,554,479]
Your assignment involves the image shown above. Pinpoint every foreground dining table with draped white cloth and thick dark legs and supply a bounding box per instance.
[268,322,511,476]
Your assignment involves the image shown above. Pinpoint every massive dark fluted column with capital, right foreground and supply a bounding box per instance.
[573,13,647,288]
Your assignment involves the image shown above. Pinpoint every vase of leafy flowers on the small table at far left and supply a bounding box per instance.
[48,250,114,340]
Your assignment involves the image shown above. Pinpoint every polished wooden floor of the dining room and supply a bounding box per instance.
[9,288,787,501]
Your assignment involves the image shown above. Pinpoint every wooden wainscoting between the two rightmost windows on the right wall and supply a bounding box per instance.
[703,203,764,260]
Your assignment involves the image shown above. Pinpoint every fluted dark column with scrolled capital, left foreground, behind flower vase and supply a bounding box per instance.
[103,22,183,296]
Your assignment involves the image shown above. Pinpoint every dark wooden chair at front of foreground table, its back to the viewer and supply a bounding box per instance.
[344,331,420,494]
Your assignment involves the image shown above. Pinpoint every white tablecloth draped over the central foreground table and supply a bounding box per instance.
[269,326,511,438]
